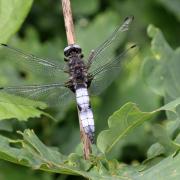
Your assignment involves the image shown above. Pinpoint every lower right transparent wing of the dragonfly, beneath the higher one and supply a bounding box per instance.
[89,45,137,95]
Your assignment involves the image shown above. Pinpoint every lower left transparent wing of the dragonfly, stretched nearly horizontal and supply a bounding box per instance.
[0,83,74,106]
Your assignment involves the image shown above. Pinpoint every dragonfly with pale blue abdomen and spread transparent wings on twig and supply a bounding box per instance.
[0,16,136,143]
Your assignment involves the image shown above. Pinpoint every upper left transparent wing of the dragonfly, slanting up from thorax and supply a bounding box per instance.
[0,44,67,82]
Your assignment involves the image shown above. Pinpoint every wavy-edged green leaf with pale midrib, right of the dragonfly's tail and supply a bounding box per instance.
[97,98,180,153]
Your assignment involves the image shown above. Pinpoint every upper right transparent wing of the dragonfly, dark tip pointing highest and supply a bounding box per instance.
[88,16,134,72]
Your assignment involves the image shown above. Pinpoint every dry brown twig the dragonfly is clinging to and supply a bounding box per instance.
[62,0,91,159]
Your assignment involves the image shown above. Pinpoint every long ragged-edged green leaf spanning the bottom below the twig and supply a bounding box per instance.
[0,129,180,180]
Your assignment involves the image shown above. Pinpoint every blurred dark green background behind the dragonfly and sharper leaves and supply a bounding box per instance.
[0,0,180,180]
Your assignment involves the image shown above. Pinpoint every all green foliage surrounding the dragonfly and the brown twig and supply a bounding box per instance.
[0,0,180,180]
